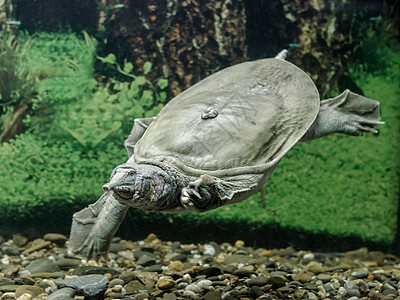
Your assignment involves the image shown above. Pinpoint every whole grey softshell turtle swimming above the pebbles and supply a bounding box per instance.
[69,51,383,258]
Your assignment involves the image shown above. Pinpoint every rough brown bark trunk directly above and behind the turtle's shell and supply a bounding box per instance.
[100,0,246,95]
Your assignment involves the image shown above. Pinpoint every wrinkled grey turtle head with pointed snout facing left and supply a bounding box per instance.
[103,163,176,211]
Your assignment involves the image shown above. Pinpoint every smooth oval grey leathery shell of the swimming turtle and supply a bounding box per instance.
[134,58,320,176]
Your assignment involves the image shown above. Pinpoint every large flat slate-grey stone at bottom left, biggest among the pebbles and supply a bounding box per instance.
[57,274,109,299]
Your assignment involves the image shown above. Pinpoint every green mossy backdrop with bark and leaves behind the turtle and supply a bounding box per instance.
[0,0,400,251]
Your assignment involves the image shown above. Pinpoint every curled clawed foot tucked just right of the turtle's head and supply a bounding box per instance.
[180,175,222,212]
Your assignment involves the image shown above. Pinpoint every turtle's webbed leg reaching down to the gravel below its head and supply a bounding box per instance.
[68,191,129,259]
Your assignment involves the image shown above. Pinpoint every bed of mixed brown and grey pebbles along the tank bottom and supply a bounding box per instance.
[0,233,400,300]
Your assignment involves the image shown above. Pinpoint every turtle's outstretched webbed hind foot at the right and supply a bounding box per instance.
[301,90,384,142]
